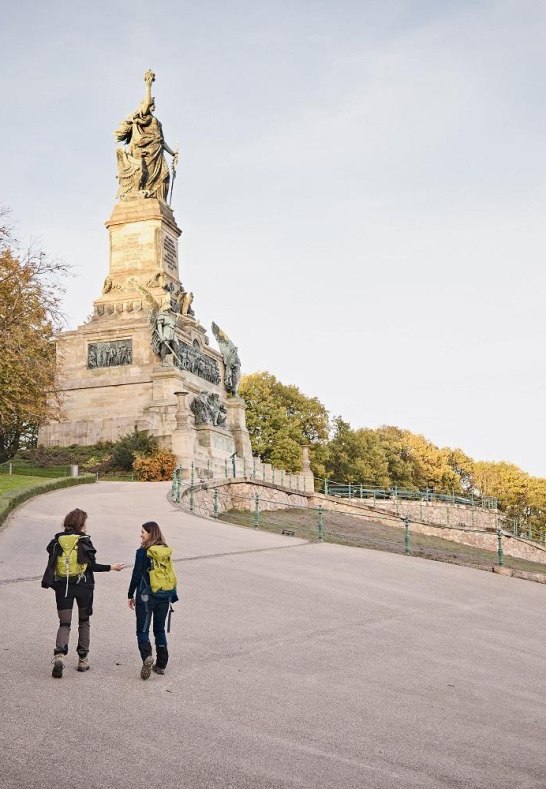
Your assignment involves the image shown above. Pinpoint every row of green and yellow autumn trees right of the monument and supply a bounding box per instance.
[240,372,546,533]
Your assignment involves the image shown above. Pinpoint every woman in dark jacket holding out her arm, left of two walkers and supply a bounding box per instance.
[42,509,125,679]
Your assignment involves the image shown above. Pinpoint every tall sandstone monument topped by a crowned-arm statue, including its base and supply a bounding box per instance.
[38,71,252,475]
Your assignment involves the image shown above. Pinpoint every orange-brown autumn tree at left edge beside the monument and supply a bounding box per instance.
[0,210,67,461]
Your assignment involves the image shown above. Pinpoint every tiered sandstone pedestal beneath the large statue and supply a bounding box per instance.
[39,188,252,474]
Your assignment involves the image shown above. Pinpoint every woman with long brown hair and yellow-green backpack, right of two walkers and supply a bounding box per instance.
[128,521,178,679]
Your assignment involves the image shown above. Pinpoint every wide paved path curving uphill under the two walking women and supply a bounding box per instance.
[0,483,546,789]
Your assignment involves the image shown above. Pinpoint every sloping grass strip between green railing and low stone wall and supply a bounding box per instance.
[220,509,546,573]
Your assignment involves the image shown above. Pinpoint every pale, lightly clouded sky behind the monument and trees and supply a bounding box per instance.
[0,0,546,476]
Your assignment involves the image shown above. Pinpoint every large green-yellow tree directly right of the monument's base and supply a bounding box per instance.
[239,372,329,477]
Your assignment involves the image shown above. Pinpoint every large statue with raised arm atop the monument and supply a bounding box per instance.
[115,71,178,202]
